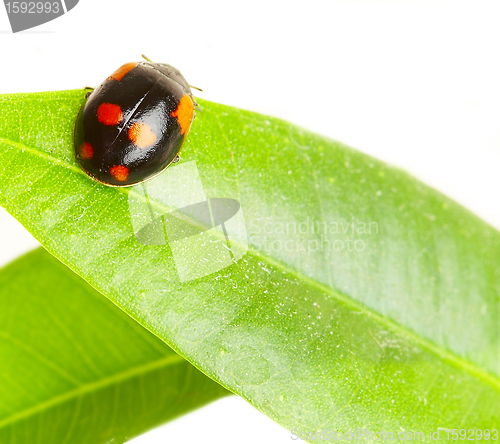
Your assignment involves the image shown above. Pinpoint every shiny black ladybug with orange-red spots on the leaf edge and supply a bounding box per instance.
[74,56,197,187]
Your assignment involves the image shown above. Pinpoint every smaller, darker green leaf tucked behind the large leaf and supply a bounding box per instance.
[0,249,227,444]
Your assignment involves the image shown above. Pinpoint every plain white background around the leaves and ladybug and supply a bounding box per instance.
[0,0,500,444]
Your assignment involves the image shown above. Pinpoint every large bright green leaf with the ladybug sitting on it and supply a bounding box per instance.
[0,91,500,433]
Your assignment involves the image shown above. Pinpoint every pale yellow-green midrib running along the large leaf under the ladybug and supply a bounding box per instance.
[0,134,500,392]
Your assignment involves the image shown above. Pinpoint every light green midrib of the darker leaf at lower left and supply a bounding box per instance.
[0,354,186,429]
